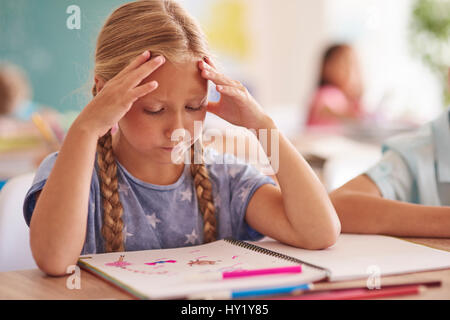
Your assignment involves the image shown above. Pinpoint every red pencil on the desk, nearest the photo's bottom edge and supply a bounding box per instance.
[276,285,426,300]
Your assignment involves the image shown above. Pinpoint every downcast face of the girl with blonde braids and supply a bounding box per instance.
[119,60,208,163]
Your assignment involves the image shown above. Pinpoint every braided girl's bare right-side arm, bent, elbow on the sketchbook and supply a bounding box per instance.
[246,120,341,250]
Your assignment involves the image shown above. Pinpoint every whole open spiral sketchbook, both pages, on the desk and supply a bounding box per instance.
[79,234,450,299]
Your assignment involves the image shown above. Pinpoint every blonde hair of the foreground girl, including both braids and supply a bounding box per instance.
[92,0,216,252]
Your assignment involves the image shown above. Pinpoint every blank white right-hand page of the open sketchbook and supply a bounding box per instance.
[257,234,450,281]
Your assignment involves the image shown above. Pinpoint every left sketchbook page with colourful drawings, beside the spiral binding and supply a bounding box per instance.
[78,239,327,299]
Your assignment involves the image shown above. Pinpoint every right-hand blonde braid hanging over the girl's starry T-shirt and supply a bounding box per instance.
[191,141,217,243]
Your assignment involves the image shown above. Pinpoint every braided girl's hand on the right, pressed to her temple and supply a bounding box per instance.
[199,58,272,130]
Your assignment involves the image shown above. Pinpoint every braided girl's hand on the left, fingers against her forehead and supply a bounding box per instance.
[74,51,165,138]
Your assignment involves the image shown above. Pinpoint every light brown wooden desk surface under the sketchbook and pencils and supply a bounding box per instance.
[0,239,450,300]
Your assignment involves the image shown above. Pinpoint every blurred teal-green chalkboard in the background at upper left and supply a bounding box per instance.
[0,0,127,111]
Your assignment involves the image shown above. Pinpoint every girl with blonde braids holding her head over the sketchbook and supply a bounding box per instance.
[24,0,340,275]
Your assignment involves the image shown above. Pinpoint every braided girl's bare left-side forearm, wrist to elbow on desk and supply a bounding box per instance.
[30,126,97,276]
